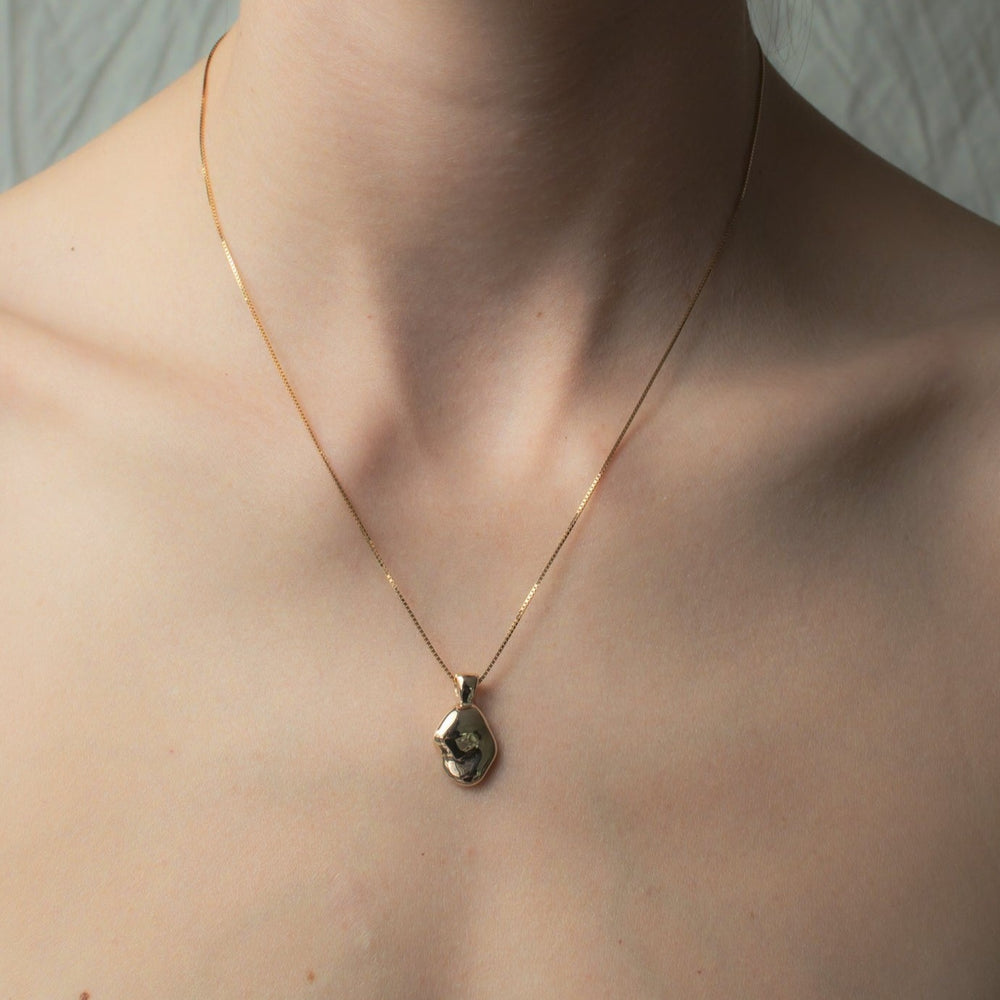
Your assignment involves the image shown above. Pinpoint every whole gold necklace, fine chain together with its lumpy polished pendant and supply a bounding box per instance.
[199,36,767,786]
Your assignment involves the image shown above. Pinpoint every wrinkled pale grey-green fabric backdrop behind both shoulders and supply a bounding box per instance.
[0,0,1000,222]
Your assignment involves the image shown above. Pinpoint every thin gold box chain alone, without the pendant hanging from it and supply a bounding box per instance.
[199,36,767,684]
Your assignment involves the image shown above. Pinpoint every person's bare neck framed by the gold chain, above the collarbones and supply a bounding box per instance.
[207,0,759,464]
